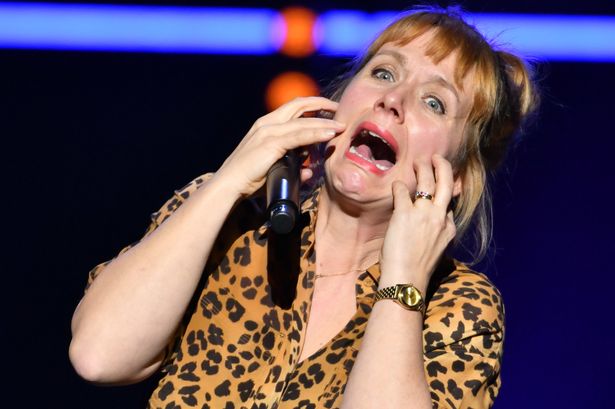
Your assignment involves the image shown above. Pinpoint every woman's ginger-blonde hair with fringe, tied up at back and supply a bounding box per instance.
[331,7,538,262]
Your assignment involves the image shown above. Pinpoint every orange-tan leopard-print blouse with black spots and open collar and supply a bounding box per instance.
[88,175,504,409]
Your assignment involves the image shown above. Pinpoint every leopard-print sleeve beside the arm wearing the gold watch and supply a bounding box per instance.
[423,268,504,409]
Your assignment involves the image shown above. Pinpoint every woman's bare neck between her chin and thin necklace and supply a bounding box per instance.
[315,186,390,275]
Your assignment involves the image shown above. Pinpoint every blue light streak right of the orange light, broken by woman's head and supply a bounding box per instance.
[316,10,615,62]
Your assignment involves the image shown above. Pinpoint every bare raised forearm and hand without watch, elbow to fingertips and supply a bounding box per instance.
[70,97,344,383]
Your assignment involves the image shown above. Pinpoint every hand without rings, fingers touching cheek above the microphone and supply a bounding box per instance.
[215,97,345,197]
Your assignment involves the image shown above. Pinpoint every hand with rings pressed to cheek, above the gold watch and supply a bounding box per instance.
[380,155,456,294]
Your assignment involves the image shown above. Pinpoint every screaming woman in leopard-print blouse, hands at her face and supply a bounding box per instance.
[70,10,536,408]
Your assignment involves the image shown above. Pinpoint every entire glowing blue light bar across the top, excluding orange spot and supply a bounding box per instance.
[0,2,615,62]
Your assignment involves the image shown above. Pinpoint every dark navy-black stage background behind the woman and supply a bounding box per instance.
[0,0,615,409]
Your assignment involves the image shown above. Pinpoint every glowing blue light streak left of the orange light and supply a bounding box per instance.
[0,3,284,54]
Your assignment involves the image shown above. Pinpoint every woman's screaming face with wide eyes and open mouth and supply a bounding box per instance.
[325,33,473,207]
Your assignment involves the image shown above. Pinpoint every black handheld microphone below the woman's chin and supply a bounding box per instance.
[266,149,301,234]
